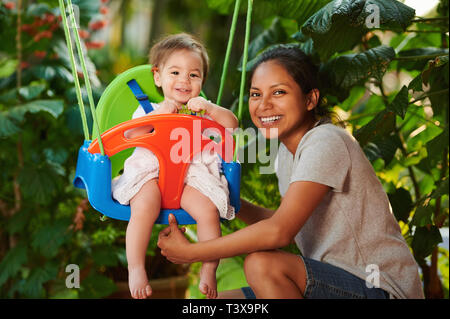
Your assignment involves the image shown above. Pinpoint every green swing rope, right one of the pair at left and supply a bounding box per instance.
[67,0,105,155]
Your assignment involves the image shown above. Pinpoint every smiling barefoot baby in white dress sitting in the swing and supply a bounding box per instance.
[112,33,238,298]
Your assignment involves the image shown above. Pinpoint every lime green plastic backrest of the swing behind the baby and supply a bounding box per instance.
[92,64,164,178]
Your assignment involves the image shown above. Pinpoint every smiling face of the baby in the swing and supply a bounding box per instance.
[154,50,203,104]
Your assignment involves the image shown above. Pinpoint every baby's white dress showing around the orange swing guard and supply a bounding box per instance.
[111,103,235,219]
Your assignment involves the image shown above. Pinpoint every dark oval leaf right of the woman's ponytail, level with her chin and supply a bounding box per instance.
[354,110,395,146]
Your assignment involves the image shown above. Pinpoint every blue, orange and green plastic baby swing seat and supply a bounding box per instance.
[73,65,241,224]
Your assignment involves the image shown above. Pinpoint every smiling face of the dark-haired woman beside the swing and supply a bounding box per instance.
[249,60,315,142]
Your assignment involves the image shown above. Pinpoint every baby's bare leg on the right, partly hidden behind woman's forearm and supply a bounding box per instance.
[181,185,220,299]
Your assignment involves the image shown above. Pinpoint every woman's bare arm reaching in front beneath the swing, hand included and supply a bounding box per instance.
[158,181,330,263]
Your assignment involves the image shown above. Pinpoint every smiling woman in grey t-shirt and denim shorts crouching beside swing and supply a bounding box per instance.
[158,46,423,298]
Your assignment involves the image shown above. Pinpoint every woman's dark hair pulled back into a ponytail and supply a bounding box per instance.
[249,44,332,119]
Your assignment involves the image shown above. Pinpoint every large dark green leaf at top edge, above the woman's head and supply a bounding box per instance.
[301,0,415,60]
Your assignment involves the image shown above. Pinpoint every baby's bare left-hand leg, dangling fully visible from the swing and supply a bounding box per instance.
[126,179,161,299]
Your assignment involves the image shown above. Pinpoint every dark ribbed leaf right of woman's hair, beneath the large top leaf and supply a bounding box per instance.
[320,45,395,98]
